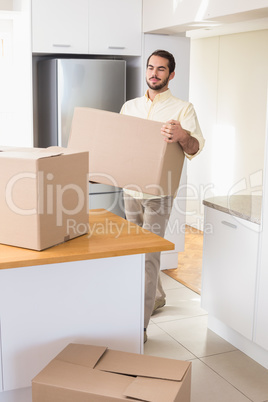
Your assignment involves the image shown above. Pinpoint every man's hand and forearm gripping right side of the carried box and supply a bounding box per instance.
[161,120,199,155]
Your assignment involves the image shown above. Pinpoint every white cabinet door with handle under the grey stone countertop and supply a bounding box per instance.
[201,207,259,340]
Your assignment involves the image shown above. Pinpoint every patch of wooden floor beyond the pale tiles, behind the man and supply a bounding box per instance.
[163,226,203,294]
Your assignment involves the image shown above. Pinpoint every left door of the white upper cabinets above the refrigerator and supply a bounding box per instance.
[32,0,88,53]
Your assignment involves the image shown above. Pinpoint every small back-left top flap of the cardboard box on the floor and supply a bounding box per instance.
[55,343,107,369]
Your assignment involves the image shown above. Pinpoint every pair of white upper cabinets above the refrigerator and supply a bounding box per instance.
[32,0,142,56]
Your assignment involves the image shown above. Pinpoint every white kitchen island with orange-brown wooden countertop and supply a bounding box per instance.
[0,210,174,402]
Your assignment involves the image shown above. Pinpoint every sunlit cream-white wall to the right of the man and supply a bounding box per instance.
[187,30,268,229]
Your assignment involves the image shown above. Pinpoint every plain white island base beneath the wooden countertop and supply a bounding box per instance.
[0,254,144,392]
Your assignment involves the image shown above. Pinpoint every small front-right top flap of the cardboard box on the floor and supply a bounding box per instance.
[124,377,181,402]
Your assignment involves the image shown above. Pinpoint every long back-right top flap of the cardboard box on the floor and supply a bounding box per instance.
[95,349,191,381]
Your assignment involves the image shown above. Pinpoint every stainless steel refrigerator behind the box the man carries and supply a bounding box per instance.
[37,58,126,216]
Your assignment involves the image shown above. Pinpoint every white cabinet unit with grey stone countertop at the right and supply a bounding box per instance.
[201,195,268,368]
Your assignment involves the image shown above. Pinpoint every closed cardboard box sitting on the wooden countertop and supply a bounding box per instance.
[0,147,89,250]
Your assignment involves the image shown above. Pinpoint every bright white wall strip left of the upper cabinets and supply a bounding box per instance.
[0,0,33,147]
